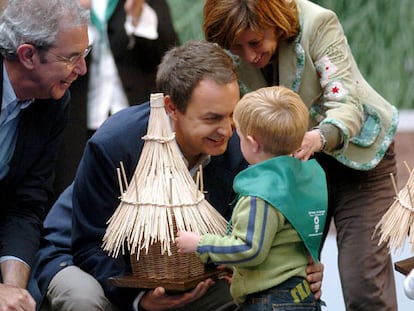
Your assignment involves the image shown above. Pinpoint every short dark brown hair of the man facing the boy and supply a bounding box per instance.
[156,41,237,113]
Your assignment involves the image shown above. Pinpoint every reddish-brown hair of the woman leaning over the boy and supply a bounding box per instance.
[203,0,299,49]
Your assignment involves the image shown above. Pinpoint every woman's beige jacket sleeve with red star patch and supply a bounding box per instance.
[303,10,364,147]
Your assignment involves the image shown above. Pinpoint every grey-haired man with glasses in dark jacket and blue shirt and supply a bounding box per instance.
[0,0,90,310]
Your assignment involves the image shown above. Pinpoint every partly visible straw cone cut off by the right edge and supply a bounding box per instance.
[374,162,414,255]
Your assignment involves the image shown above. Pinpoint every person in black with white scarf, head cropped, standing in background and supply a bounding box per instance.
[55,0,178,200]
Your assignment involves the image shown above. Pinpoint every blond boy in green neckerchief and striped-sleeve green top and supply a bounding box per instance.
[176,86,327,310]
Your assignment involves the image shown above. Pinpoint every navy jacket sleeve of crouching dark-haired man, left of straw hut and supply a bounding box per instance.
[72,105,148,310]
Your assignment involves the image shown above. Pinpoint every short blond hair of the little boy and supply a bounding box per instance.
[233,86,309,155]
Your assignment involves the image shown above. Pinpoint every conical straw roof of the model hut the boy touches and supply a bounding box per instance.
[103,93,227,261]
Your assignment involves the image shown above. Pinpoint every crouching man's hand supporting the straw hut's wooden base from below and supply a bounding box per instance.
[140,279,214,311]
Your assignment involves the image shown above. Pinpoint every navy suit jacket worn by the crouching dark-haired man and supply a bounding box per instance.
[35,103,247,310]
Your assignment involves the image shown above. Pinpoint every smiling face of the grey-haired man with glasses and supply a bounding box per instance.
[32,25,89,99]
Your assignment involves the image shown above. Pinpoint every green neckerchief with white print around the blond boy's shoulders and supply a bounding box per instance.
[233,156,328,261]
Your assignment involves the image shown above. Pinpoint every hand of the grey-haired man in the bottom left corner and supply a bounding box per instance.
[0,284,36,311]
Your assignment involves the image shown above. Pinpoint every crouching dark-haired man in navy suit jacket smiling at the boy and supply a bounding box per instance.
[31,42,321,310]
